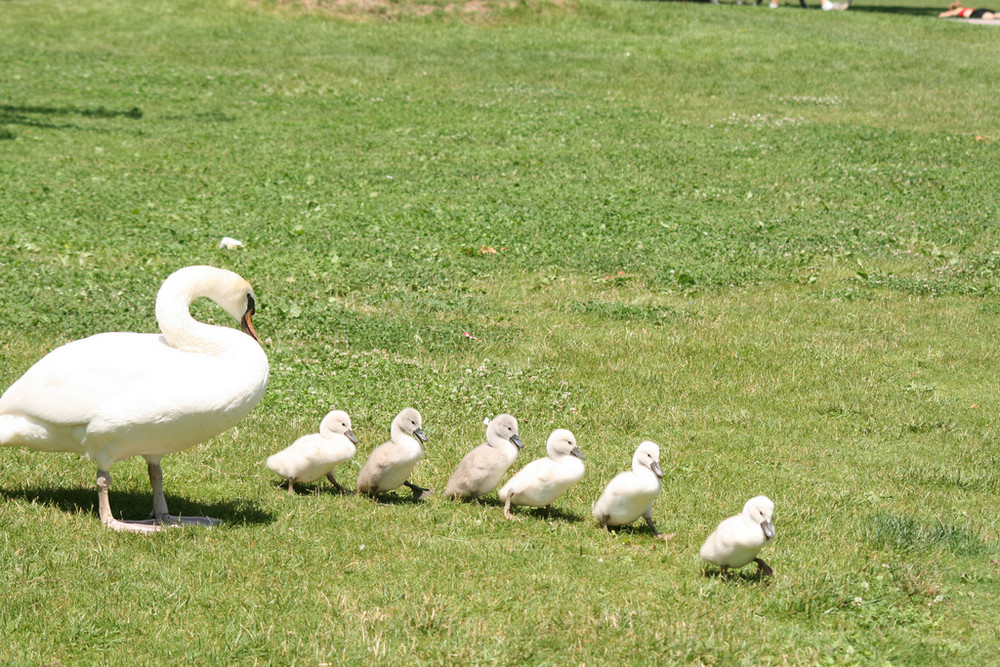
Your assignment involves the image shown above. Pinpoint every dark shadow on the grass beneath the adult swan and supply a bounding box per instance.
[0,487,274,525]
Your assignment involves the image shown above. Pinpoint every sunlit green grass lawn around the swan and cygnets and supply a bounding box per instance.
[0,0,1000,665]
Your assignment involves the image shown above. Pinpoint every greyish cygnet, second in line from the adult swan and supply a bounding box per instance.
[358,408,430,500]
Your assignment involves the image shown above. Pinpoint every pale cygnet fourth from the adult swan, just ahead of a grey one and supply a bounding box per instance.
[497,428,584,520]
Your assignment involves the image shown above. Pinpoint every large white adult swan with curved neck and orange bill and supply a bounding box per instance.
[0,266,268,533]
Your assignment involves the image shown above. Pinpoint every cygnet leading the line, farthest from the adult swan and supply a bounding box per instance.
[700,496,774,577]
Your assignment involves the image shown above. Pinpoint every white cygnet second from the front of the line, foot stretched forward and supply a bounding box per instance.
[593,440,673,540]
